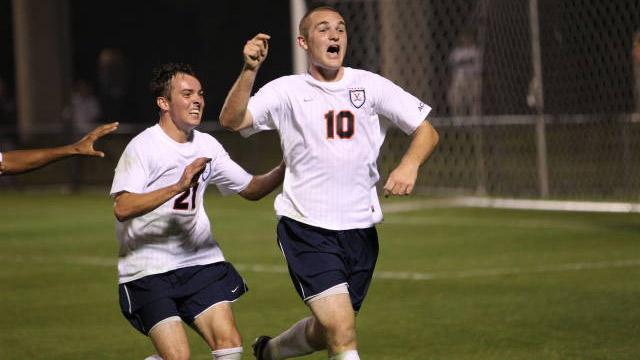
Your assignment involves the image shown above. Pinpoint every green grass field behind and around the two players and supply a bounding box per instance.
[0,190,640,360]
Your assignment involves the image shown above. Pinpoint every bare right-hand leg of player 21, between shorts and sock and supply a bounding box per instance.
[193,302,242,350]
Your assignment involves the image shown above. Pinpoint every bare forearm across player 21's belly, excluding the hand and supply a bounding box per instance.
[113,185,182,221]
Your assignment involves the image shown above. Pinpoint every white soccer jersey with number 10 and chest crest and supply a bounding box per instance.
[243,68,431,230]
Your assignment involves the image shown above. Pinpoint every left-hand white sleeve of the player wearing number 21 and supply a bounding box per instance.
[110,142,148,196]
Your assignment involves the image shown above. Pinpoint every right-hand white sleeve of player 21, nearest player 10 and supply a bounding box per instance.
[209,144,253,195]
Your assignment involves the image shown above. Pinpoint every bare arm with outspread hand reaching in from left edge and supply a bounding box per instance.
[0,122,118,174]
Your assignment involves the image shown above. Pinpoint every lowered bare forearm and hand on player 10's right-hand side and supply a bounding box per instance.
[384,121,439,196]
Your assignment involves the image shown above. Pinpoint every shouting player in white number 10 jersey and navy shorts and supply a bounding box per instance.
[220,7,438,360]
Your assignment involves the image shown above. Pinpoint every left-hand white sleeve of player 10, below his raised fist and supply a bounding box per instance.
[240,81,284,137]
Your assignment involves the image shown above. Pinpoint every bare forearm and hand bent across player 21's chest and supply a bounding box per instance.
[113,157,211,221]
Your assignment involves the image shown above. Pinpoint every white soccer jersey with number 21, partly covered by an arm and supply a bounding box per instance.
[111,125,252,283]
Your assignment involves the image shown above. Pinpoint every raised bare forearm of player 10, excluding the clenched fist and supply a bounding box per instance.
[220,65,256,131]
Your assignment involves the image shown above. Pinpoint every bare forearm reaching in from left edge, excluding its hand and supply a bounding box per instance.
[2,145,77,174]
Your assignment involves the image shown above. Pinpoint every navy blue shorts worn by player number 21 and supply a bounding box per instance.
[118,261,248,335]
